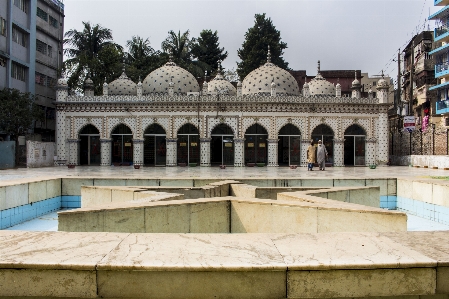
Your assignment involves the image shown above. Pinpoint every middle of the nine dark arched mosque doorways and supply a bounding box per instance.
[210,124,234,165]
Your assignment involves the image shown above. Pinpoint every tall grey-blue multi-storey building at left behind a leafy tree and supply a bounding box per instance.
[0,0,64,141]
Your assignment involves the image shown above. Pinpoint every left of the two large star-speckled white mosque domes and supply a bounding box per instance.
[143,61,200,94]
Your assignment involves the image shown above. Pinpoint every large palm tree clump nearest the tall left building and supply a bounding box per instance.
[64,22,123,95]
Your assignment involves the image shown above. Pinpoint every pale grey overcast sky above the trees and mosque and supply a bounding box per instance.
[64,0,438,81]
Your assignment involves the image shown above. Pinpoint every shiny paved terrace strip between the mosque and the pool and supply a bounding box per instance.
[0,166,449,181]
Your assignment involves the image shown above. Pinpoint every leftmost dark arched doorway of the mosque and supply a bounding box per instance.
[79,124,101,165]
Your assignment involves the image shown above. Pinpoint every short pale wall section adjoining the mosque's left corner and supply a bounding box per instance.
[27,140,56,168]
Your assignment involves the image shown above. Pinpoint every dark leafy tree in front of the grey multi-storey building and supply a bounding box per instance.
[0,88,45,165]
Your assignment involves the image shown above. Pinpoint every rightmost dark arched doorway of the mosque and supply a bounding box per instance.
[344,124,366,166]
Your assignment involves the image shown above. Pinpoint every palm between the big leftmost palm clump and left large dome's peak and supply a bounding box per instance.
[126,36,167,82]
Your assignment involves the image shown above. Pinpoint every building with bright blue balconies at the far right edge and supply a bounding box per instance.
[429,0,449,126]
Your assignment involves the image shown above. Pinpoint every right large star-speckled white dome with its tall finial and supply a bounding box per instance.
[242,48,299,95]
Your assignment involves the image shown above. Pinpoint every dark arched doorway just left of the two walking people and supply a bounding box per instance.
[278,124,301,165]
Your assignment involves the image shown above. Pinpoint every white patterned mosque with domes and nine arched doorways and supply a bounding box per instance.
[55,50,390,167]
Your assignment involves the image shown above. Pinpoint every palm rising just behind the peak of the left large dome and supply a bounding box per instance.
[161,30,207,77]
